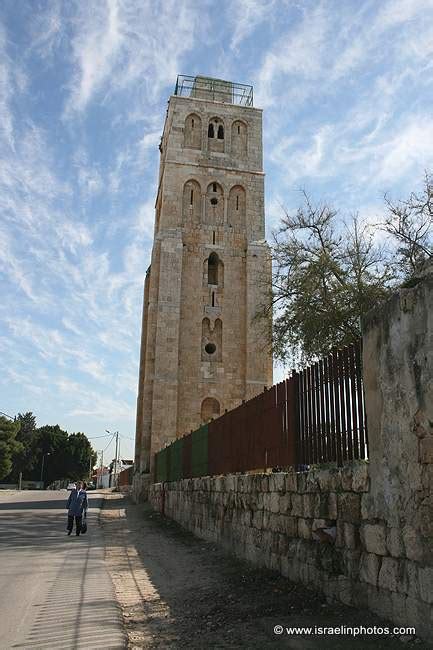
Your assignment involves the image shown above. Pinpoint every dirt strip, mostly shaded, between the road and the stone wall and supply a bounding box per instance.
[101,494,431,650]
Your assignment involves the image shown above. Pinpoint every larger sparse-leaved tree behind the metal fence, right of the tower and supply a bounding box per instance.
[261,192,395,363]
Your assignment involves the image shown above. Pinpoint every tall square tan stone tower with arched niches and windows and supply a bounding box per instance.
[135,77,272,474]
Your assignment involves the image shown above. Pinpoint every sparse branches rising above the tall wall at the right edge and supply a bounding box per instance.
[382,172,433,282]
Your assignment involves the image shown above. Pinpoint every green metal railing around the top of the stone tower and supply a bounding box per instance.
[174,74,253,106]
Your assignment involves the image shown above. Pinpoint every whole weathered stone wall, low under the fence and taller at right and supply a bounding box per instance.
[149,267,433,641]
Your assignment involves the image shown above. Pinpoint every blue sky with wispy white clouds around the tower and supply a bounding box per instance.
[0,0,433,457]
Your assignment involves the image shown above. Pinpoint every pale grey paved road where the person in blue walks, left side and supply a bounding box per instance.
[0,491,126,650]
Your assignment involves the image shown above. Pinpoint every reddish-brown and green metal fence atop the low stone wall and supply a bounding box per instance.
[155,341,368,482]
